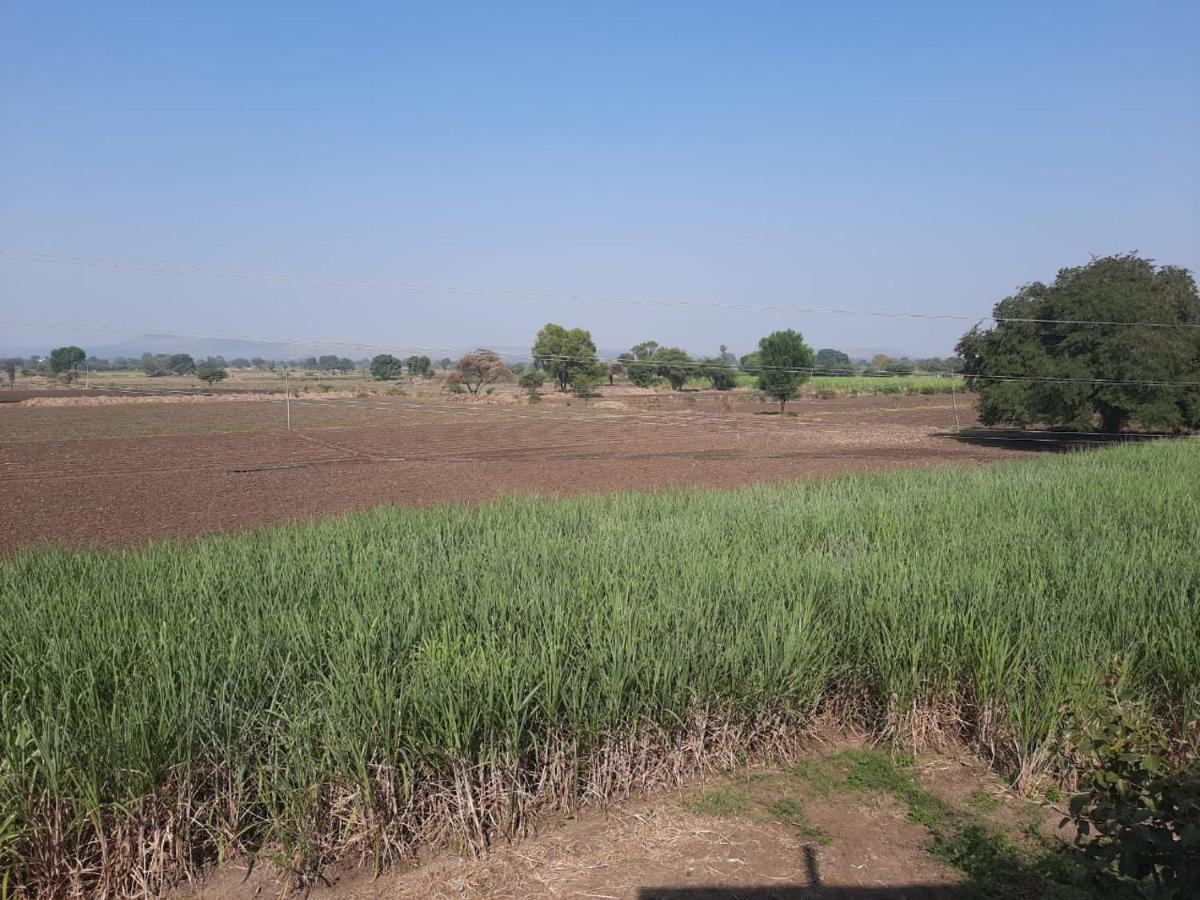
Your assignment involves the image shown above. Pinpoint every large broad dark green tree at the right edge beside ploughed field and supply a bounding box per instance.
[958,253,1200,433]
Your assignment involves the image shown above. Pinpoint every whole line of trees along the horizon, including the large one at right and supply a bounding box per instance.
[14,253,1200,433]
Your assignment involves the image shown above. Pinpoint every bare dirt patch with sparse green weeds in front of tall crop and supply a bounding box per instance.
[175,748,1075,900]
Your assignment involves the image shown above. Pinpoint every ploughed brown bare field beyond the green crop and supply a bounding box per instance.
[0,389,1045,552]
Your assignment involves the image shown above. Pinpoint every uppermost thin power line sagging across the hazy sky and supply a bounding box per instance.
[0,247,1200,328]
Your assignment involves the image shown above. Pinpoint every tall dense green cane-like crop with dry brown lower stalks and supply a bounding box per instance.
[0,440,1200,894]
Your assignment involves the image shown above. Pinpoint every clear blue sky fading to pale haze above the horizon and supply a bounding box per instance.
[0,0,1200,354]
